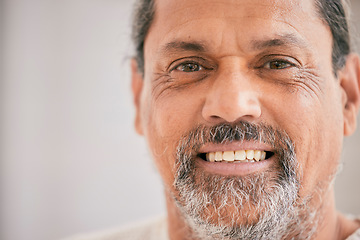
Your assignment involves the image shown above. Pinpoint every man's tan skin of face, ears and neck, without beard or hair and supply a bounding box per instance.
[132,0,360,240]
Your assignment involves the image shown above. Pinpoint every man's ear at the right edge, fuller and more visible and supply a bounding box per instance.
[339,54,360,136]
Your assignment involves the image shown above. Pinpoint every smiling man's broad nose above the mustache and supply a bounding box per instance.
[202,67,261,123]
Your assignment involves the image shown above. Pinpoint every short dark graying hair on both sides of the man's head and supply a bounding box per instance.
[132,0,351,76]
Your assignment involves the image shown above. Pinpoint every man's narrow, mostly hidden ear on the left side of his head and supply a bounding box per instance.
[131,58,144,135]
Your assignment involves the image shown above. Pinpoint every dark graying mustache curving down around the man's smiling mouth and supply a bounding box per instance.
[176,121,302,183]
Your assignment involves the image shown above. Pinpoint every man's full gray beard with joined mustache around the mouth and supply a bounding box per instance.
[173,122,319,240]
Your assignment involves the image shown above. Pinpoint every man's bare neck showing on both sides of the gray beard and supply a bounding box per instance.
[166,190,360,240]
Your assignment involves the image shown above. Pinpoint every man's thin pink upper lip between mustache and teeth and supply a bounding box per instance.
[199,140,274,153]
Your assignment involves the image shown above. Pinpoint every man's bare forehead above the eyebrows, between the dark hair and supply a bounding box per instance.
[145,0,331,59]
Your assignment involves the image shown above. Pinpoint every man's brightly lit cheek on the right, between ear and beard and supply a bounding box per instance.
[274,79,342,196]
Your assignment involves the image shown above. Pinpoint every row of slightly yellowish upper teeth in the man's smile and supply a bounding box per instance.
[206,150,266,163]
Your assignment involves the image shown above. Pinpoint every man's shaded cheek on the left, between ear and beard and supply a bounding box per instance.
[142,87,200,187]
